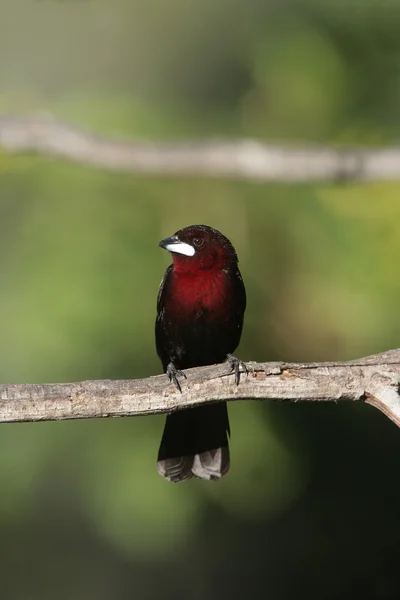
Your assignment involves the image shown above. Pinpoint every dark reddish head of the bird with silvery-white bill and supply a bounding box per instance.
[159,225,238,271]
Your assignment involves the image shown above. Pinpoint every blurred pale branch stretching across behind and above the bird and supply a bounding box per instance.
[0,116,400,183]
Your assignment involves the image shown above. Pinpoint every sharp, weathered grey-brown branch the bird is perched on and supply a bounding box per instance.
[0,350,400,426]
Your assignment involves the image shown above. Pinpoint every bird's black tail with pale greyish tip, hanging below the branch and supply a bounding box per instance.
[158,402,230,483]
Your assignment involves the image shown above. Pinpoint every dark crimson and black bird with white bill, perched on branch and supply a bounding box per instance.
[155,225,247,483]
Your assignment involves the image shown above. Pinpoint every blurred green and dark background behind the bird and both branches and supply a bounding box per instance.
[0,0,400,600]
